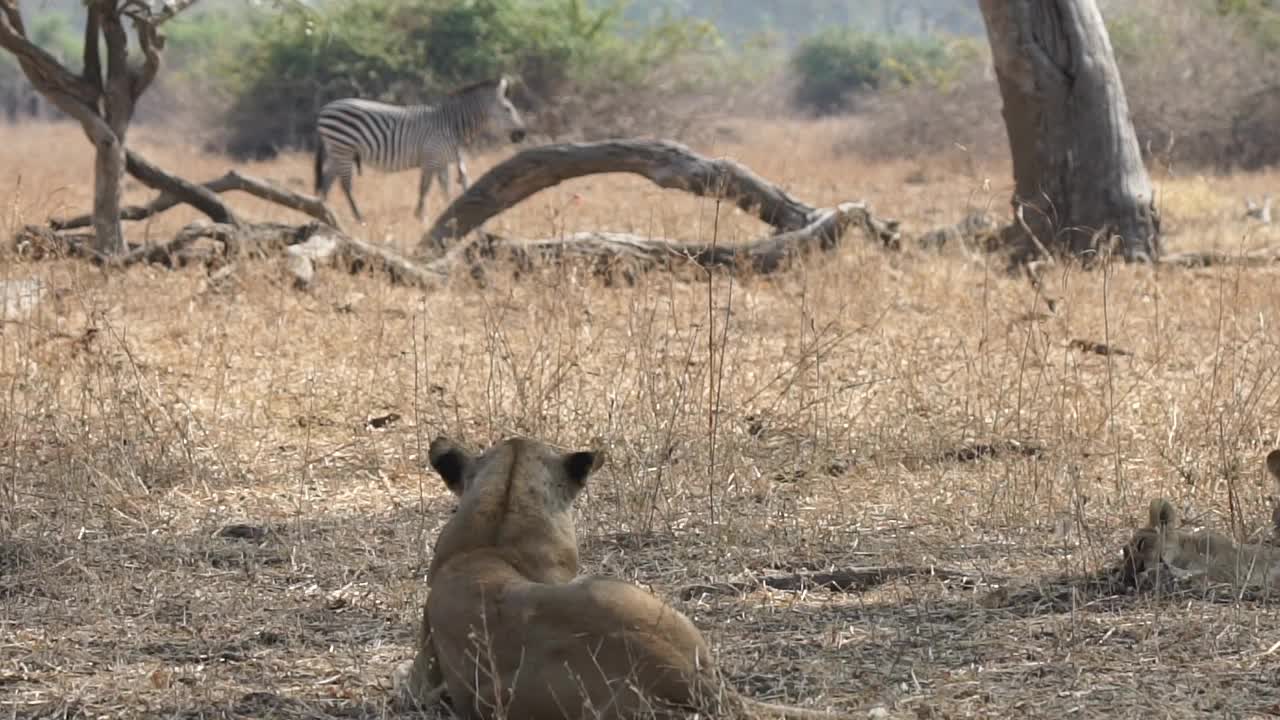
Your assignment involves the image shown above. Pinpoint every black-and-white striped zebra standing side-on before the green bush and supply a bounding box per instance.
[315,76,526,223]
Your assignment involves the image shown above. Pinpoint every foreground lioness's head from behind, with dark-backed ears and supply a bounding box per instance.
[428,437,604,583]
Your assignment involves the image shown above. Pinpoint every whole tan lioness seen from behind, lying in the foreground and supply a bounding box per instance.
[394,438,842,720]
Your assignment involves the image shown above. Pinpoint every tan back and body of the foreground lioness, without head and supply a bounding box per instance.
[428,552,712,719]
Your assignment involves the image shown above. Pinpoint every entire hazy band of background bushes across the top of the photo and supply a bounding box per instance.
[0,0,1280,169]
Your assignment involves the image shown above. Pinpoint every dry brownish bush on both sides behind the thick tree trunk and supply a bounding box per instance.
[837,0,1280,170]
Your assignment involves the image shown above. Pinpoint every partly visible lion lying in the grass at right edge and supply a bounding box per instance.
[1123,497,1280,585]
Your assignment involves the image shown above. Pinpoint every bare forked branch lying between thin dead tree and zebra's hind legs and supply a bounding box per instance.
[49,166,338,231]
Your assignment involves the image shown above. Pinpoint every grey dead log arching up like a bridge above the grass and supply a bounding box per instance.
[416,140,899,254]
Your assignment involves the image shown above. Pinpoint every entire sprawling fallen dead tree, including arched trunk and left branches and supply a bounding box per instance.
[18,140,899,288]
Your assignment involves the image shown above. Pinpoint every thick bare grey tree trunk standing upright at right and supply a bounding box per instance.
[979,0,1160,260]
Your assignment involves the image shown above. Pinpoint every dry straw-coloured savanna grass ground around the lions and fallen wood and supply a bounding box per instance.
[0,122,1280,719]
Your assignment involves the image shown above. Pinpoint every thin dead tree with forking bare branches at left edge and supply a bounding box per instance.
[0,0,225,256]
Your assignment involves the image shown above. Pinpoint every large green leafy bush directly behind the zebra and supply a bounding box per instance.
[209,0,721,156]
